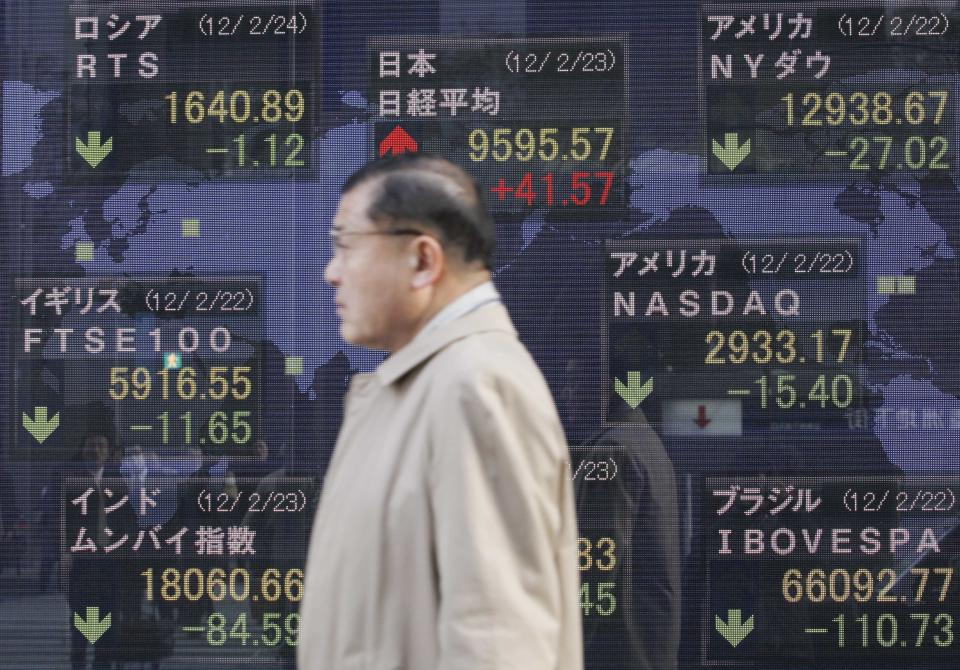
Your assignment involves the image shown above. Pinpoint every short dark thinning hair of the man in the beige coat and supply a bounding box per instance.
[342,153,496,269]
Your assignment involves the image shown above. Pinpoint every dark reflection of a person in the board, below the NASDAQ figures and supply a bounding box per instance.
[563,359,681,670]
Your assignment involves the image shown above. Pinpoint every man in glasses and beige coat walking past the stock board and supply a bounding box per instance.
[297,155,583,670]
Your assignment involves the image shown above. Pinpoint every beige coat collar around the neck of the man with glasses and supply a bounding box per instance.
[374,302,517,386]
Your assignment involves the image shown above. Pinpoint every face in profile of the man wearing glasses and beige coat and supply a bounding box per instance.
[326,182,415,351]
